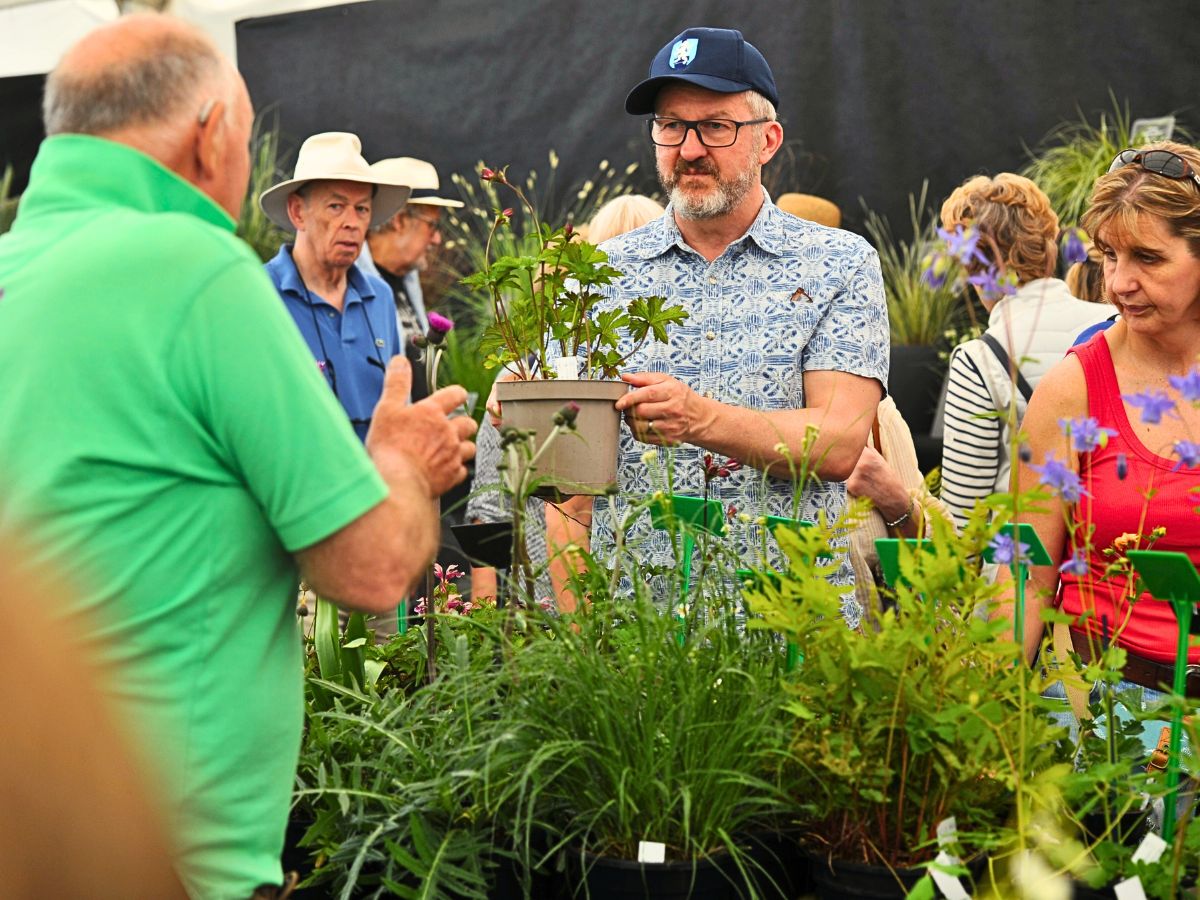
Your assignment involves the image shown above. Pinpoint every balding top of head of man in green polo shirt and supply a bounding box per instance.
[42,14,235,137]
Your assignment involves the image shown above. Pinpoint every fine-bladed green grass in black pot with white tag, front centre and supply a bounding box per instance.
[496,489,802,900]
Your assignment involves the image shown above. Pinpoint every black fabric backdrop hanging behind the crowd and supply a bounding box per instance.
[238,0,1200,233]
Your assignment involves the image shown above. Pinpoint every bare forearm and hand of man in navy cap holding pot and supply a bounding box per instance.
[617,371,883,481]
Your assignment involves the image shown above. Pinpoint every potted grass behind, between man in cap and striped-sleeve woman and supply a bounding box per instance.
[863,181,968,472]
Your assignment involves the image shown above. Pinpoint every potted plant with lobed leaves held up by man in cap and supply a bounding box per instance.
[463,167,686,496]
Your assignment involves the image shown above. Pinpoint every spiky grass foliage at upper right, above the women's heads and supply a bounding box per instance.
[1021,91,1188,228]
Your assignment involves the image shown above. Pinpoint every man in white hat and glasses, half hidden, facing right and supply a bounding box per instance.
[359,156,463,400]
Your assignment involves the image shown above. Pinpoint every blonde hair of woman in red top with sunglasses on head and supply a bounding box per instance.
[1080,140,1200,258]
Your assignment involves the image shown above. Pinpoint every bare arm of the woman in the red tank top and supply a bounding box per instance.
[992,356,1087,660]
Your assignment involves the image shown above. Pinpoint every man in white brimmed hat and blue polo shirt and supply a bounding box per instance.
[258,132,409,440]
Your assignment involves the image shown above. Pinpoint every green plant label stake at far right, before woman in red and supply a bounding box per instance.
[1126,550,1200,844]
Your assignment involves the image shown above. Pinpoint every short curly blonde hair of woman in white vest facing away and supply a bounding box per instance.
[942,172,1058,284]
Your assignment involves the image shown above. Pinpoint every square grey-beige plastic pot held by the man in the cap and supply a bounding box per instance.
[496,378,629,499]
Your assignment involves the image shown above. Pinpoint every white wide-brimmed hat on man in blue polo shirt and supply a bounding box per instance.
[258,131,409,232]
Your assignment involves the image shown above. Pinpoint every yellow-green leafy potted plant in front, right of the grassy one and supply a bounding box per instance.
[748,511,1056,898]
